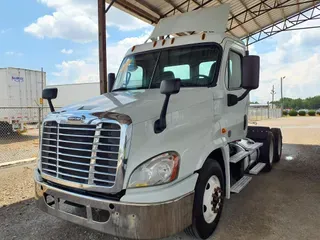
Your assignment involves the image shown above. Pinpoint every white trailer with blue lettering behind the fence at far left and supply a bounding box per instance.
[0,68,46,134]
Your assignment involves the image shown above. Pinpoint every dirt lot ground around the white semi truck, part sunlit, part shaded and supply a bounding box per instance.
[0,117,320,240]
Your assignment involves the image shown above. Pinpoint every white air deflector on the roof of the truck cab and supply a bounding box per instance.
[150,4,230,39]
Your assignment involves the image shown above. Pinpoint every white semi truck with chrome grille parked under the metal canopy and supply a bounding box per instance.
[35,5,282,239]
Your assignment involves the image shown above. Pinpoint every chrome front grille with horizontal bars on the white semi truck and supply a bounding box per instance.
[41,121,121,187]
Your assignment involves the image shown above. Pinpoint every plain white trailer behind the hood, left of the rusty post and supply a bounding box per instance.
[47,82,100,108]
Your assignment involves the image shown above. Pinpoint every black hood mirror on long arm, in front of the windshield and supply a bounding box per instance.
[154,78,181,133]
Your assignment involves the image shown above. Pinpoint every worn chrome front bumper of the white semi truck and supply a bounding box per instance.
[35,172,194,239]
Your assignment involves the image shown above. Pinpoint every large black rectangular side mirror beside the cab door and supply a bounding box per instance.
[241,56,260,90]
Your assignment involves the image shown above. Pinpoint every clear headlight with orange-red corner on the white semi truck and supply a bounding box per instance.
[128,152,180,188]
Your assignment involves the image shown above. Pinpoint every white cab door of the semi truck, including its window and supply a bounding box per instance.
[224,41,249,142]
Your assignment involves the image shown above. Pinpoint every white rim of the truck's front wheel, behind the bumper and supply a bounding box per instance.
[202,175,222,224]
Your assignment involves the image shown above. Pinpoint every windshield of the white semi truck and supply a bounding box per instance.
[113,45,220,91]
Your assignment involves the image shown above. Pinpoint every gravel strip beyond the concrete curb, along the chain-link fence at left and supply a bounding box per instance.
[0,129,39,163]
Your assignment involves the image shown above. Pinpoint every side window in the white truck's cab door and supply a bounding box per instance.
[226,51,242,90]
